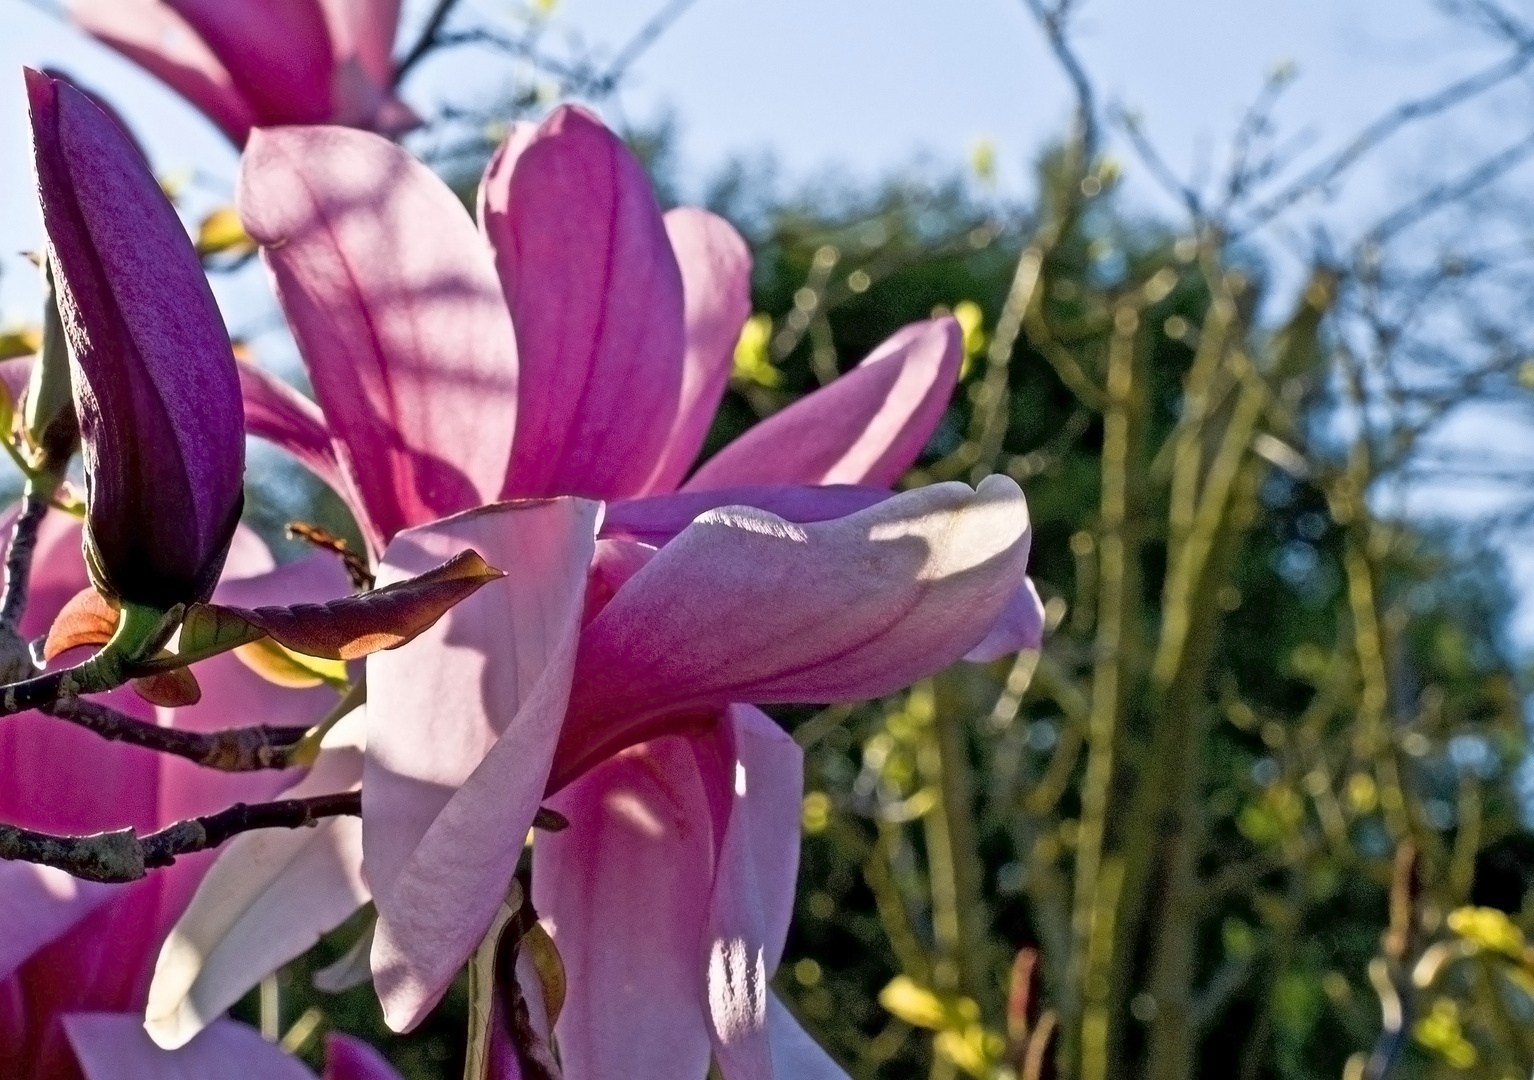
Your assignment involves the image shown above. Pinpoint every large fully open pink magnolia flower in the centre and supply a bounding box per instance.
[164,109,1039,1080]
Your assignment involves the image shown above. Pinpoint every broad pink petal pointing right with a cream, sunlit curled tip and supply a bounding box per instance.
[551,476,1031,790]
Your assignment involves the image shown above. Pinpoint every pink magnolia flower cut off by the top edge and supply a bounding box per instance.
[69,0,420,146]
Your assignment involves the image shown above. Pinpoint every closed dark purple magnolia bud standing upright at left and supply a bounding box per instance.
[26,71,245,611]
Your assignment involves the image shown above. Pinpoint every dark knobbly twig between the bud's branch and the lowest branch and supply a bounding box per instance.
[41,698,310,773]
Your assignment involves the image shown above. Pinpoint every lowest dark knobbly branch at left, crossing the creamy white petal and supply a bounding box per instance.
[0,792,362,884]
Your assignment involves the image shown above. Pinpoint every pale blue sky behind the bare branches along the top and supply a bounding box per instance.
[0,0,1534,628]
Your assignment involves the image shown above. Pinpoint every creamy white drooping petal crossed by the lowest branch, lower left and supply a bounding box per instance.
[144,713,368,1049]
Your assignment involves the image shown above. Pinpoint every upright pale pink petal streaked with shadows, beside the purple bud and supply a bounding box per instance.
[239,127,517,543]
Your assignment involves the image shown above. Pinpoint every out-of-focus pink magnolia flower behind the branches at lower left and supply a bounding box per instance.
[0,512,345,1080]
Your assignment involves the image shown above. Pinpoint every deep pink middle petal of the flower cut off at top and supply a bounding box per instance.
[166,0,334,124]
